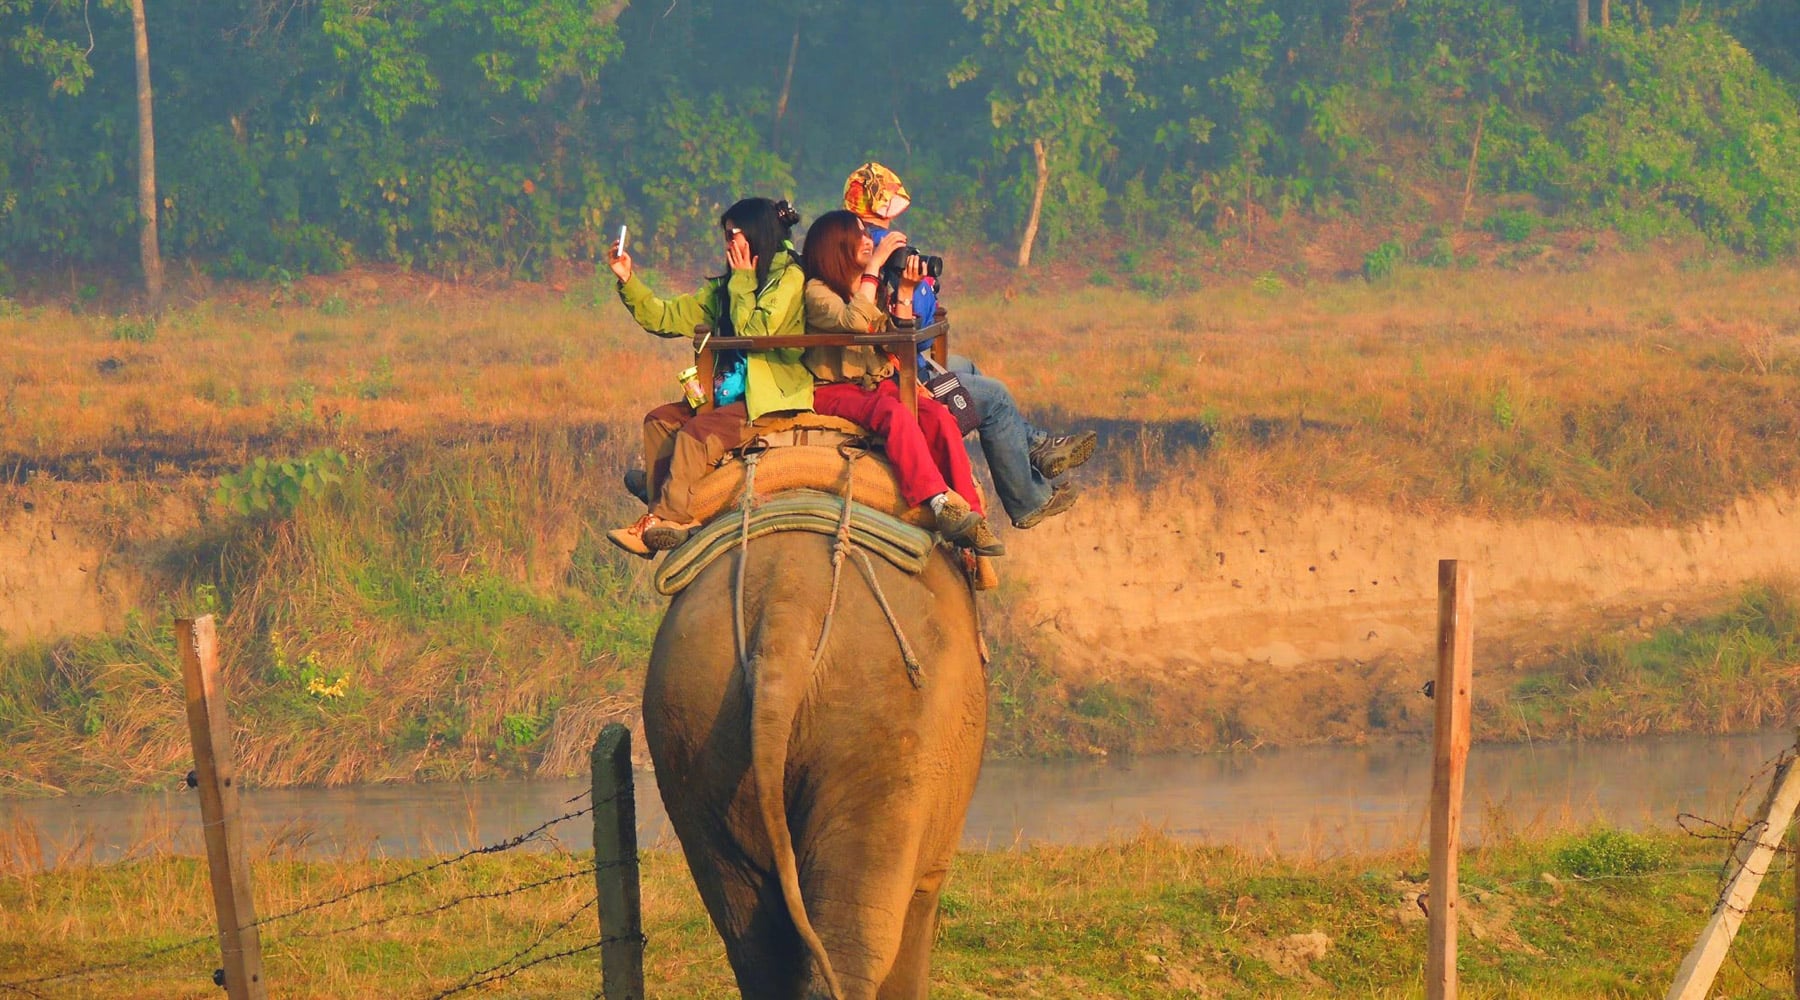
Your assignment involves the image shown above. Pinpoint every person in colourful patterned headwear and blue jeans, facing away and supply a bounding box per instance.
[844,162,1098,529]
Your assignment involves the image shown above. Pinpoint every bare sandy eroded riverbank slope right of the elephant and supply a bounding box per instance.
[1003,484,1800,745]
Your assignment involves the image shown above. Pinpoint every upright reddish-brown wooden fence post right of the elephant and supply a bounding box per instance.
[1426,559,1474,1000]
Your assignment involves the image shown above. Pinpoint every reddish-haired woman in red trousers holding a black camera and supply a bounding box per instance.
[803,212,1006,556]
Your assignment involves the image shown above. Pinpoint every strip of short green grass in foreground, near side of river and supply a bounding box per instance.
[0,831,1793,1000]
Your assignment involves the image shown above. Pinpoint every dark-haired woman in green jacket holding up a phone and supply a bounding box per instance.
[607,198,812,559]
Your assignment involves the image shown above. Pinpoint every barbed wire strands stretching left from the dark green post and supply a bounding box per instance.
[0,727,644,1000]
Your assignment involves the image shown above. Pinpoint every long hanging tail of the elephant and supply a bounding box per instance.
[745,604,844,1000]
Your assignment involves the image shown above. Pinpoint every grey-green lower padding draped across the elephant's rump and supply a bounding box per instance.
[655,489,936,597]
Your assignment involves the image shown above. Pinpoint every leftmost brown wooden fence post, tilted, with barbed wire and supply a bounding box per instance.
[175,615,268,1000]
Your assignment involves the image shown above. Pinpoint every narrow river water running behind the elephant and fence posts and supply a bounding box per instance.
[0,730,1795,867]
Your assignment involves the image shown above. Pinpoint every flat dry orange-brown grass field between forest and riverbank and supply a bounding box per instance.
[0,257,1800,522]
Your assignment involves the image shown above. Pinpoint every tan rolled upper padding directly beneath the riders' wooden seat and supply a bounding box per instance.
[688,444,934,527]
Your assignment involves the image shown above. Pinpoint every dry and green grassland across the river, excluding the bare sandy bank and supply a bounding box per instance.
[0,257,1800,793]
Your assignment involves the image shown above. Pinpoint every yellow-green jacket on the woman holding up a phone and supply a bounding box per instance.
[619,243,812,421]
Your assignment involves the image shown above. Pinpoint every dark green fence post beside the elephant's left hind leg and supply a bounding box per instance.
[590,723,644,1000]
